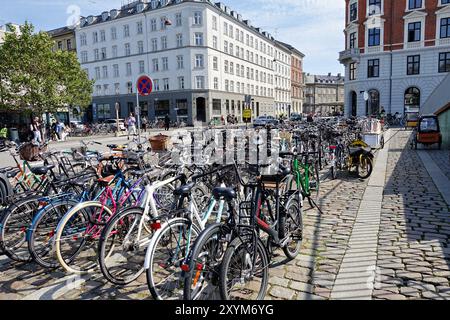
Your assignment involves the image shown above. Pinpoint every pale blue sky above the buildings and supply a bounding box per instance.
[0,0,345,74]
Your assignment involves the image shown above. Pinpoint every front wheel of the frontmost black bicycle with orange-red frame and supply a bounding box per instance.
[219,235,269,301]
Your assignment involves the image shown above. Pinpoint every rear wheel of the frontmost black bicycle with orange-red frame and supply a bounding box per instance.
[280,198,303,260]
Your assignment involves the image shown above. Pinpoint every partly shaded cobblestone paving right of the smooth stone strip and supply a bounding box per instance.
[373,131,450,299]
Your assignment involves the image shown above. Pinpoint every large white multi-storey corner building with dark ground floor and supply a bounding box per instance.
[76,0,298,123]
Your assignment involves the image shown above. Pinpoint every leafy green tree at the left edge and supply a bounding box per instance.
[0,23,93,114]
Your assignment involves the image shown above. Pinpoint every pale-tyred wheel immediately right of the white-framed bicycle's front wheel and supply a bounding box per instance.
[145,218,201,300]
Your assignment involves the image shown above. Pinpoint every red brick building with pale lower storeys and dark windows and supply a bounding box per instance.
[340,0,450,115]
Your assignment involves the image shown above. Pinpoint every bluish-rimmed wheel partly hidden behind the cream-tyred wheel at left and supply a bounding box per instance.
[27,199,78,268]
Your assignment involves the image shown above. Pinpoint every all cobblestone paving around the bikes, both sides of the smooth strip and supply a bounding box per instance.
[0,131,450,300]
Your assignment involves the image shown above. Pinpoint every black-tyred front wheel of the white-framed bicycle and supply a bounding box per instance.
[98,208,153,285]
